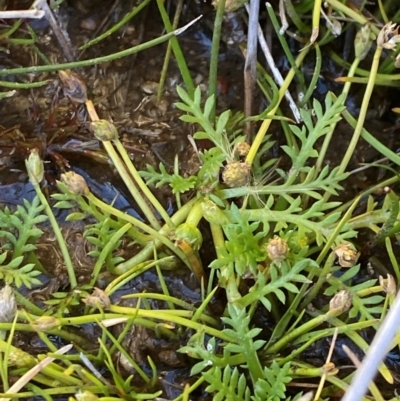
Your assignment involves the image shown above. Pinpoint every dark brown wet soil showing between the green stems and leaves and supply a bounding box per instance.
[0,0,400,399]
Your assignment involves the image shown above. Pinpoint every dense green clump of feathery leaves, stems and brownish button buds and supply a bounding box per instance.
[0,0,400,401]
